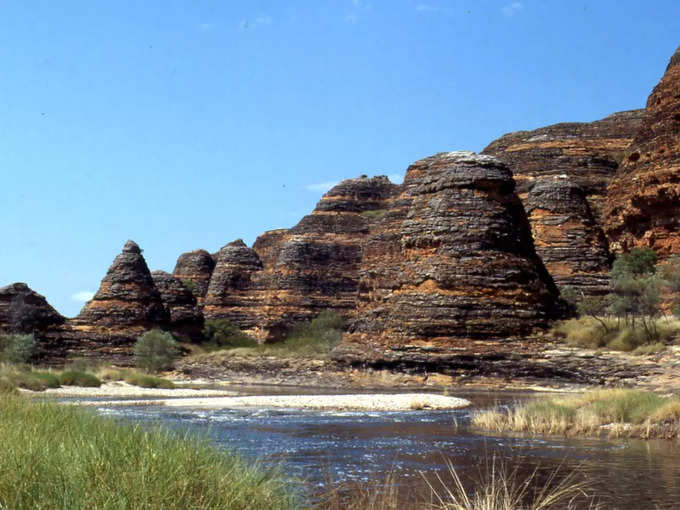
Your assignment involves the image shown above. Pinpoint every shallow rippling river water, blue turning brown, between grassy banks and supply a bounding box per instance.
[85,391,680,509]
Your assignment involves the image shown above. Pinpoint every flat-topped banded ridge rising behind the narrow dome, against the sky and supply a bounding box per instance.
[482,110,644,223]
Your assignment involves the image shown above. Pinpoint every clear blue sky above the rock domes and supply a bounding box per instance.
[0,0,680,316]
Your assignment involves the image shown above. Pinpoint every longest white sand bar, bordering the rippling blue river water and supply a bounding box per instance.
[85,393,470,411]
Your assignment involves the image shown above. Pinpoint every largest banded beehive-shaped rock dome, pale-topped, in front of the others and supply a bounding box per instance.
[336,152,560,359]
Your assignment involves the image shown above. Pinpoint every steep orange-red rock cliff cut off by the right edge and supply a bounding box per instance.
[605,48,680,258]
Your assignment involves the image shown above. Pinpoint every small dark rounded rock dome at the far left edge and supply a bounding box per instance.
[0,283,64,333]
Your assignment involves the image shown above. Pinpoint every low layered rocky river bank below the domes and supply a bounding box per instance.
[170,342,680,393]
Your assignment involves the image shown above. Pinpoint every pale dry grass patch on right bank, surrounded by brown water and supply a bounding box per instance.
[472,389,680,439]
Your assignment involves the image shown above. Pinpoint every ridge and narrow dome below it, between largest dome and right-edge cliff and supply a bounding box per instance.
[484,110,643,294]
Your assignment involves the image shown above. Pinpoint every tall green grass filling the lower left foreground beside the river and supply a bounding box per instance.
[0,396,296,510]
